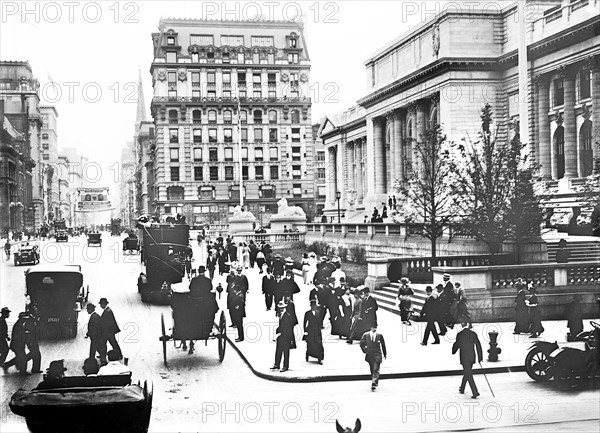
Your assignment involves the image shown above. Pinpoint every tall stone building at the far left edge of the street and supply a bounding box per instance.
[0,61,41,231]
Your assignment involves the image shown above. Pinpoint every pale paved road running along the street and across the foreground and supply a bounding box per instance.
[0,233,600,432]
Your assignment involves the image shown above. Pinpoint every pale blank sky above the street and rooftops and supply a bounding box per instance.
[0,0,476,197]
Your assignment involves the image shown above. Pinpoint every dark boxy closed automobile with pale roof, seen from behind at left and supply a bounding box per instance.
[25,265,90,340]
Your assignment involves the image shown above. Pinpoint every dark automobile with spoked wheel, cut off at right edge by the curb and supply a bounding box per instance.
[525,322,600,388]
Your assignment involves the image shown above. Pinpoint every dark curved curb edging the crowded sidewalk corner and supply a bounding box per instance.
[225,336,525,383]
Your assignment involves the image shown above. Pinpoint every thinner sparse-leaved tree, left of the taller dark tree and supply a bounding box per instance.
[396,125,457,261]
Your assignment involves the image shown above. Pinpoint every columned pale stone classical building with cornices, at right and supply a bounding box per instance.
[320,0,600,220]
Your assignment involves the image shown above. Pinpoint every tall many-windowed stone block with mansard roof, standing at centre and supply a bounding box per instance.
[150,19,315,223]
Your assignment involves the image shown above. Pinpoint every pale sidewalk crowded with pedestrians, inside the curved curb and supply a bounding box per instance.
[198,255,589,382]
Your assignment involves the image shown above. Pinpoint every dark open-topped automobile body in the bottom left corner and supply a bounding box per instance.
[9,369,153,432]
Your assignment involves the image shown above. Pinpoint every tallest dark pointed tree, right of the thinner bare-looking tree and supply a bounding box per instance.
[456,104,524,254]
